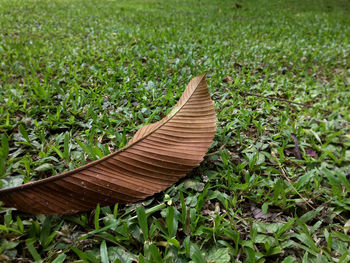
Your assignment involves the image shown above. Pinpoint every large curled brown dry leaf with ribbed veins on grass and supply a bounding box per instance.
[0,75,216,214]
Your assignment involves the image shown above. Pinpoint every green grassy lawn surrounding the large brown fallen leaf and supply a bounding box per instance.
[0,0,350,263]
